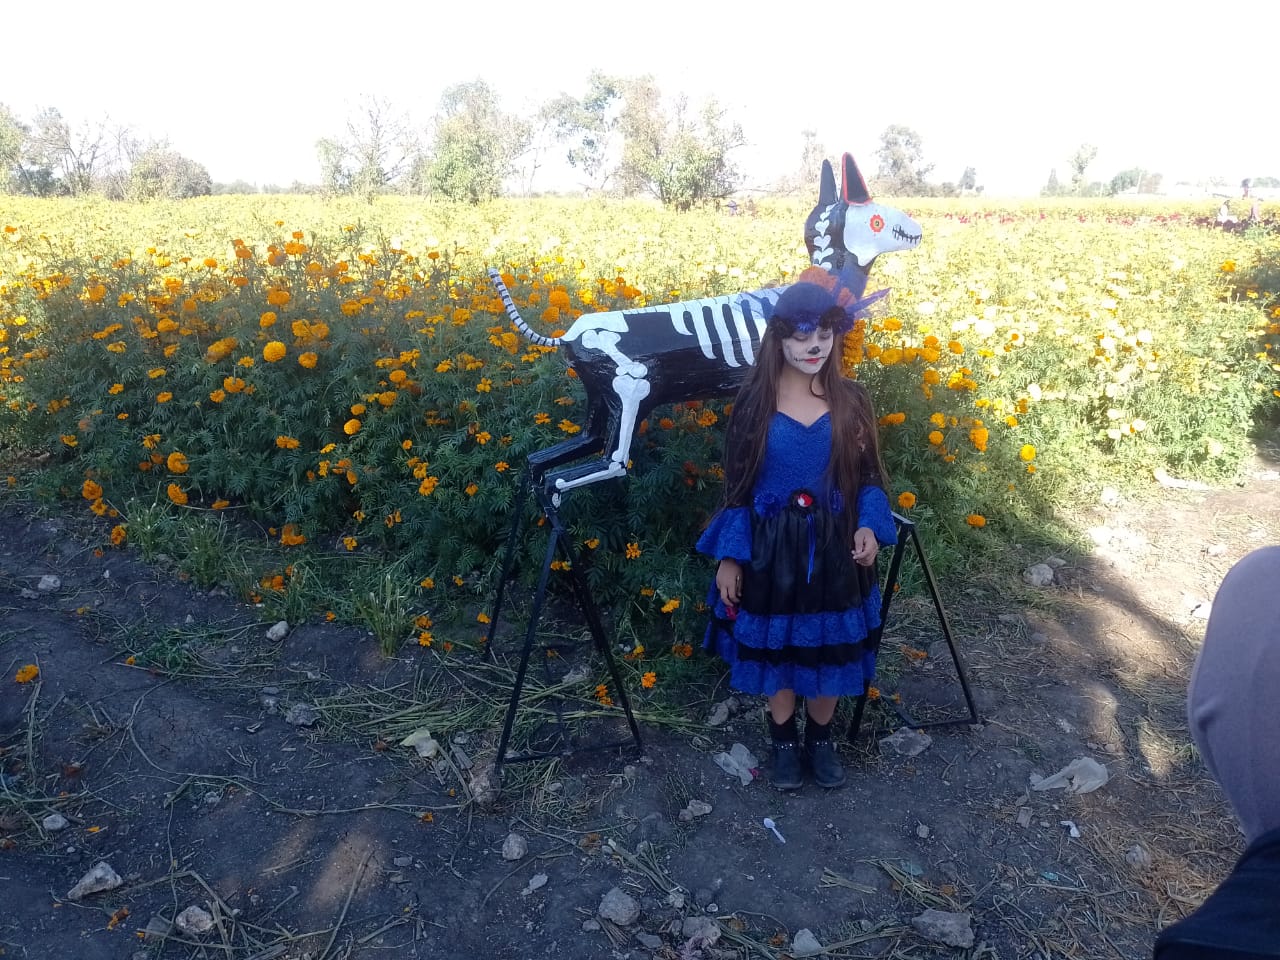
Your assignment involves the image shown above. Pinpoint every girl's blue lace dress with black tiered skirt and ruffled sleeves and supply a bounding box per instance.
[698,413,897,696]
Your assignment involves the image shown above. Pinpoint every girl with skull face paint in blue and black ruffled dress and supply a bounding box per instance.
[698,273,896,790]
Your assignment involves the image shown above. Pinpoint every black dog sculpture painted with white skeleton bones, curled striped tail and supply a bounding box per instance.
[489,154,920,493]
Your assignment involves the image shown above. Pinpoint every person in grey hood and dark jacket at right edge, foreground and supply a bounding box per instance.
[1155,547,1280,960]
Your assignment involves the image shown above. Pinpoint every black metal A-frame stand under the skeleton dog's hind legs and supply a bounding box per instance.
[486,477,644,781]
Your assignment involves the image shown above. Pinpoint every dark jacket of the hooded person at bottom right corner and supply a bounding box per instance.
[1155,829,1280,960]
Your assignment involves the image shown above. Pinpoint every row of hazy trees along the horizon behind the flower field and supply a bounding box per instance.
[0,70,1039,210]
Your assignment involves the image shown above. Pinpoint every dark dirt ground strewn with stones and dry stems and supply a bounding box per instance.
[0,445,1280,960]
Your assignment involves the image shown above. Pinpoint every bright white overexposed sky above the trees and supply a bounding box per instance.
[0,0,1280,195]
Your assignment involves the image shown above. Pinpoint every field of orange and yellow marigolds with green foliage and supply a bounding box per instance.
[0,197,1280,655]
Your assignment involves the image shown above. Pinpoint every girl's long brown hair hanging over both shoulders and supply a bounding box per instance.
[724,323,886,543]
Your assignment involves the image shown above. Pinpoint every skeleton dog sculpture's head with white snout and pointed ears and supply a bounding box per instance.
[804,154,922,297]
